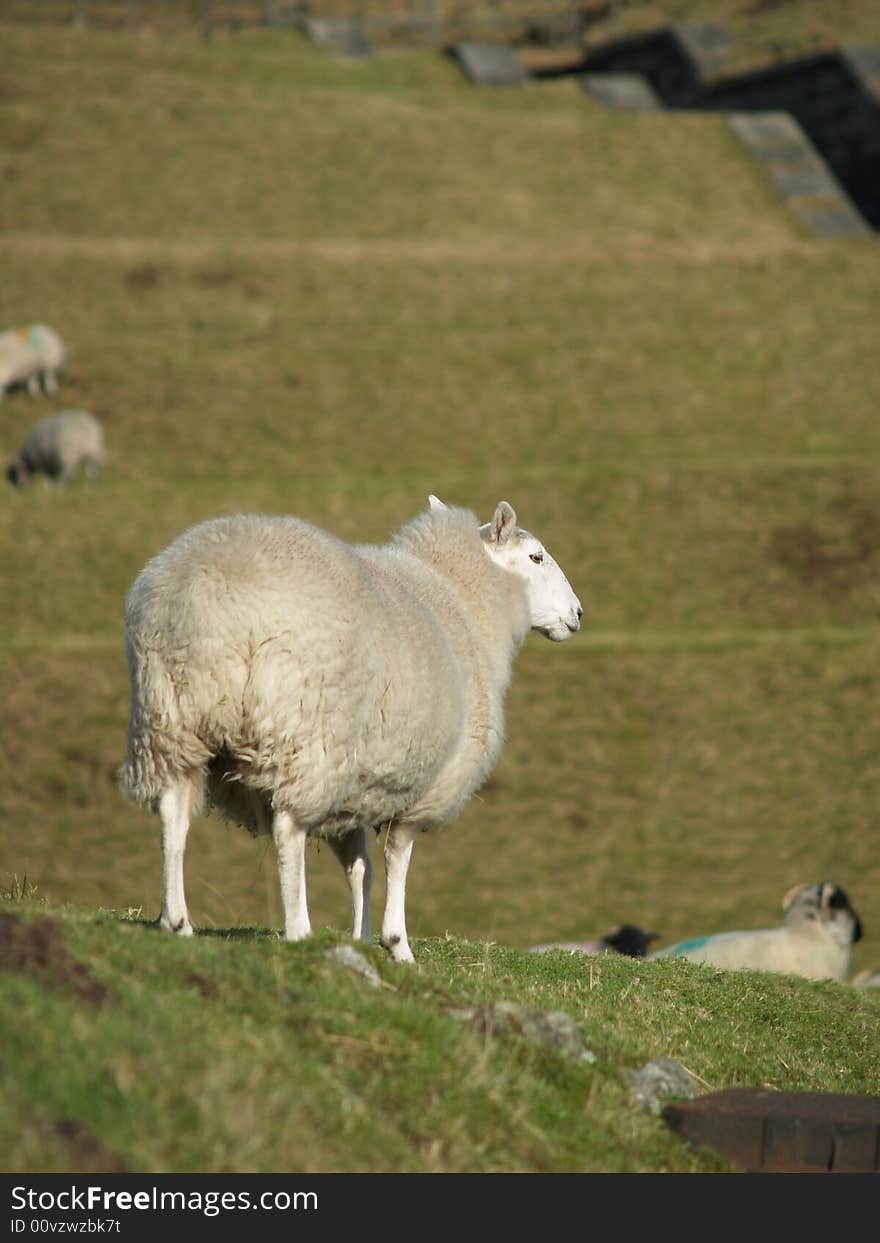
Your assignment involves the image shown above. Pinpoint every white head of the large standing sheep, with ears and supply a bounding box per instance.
[429,496,583,643]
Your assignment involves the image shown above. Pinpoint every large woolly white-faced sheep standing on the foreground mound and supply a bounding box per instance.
[119,496,582,962]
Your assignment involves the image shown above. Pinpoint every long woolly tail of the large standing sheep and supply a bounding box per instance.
[117,645,210,810]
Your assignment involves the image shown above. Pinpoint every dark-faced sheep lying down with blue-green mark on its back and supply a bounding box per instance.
[649,881,861,981]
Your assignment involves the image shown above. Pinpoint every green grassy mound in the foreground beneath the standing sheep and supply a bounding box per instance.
[0,901,880,1173]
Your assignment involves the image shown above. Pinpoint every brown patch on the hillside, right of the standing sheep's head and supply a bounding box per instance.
[769,497,880,595]
